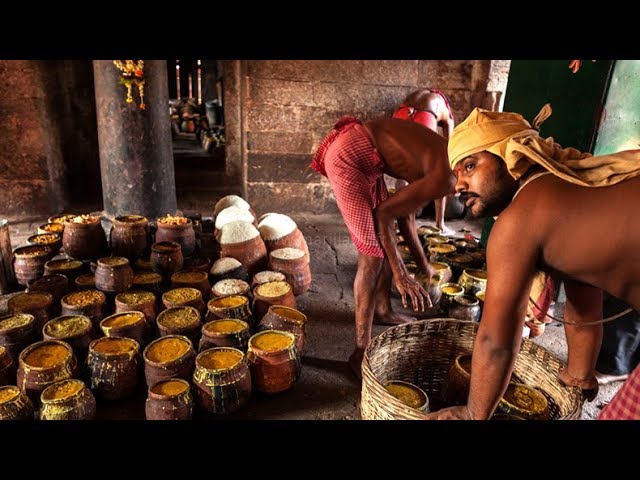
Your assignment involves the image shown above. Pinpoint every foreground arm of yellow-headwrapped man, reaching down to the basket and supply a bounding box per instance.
[429,208,539,420]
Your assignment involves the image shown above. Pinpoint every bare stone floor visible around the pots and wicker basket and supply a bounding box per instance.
[0,213,621,419]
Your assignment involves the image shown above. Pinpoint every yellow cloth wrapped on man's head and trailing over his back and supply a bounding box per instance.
[449,104,640,187]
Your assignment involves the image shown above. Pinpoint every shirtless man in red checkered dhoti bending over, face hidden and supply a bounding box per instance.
[311,117,455,377]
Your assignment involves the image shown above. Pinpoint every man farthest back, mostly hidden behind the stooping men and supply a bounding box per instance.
[393,88,455,235]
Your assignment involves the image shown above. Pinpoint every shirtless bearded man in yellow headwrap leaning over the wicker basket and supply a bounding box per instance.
[429,105,640,419]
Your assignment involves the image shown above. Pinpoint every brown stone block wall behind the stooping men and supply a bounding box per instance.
[231,60,510,212]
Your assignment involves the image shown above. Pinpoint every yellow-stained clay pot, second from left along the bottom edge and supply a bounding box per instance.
[40,379,96,420]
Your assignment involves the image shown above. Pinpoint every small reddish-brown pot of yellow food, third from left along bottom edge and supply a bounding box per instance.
[144,378,193,420]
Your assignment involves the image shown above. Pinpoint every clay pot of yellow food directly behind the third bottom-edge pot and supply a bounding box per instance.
[142,335,196,386]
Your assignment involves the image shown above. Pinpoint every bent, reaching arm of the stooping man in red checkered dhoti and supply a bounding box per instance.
[374,171,455,311]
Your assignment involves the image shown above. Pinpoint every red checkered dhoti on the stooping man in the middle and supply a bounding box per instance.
[311,117,389,258]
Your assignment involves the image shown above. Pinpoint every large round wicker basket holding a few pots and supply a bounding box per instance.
[361,319,583,420]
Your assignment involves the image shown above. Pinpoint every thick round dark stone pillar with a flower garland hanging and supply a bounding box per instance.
[93,60,177,219]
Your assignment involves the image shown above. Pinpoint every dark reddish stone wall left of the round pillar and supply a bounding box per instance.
[0,60,101,221]
